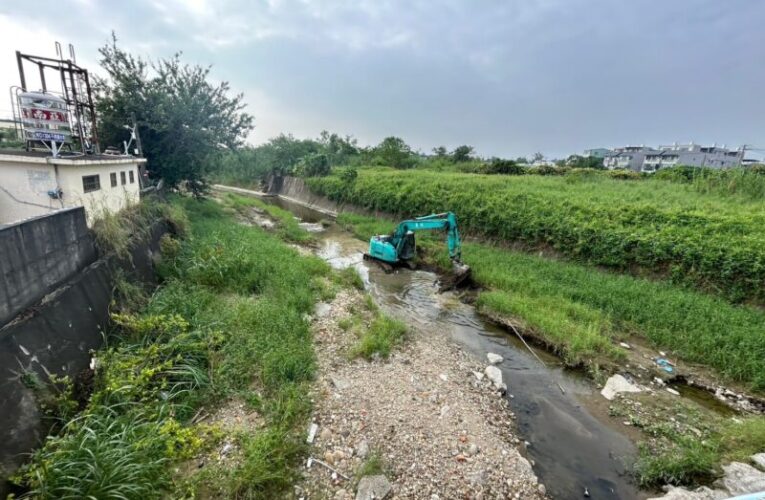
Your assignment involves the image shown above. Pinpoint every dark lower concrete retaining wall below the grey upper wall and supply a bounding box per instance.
[0,215,169,498]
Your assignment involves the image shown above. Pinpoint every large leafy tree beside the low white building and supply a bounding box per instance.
[94,35,253,195]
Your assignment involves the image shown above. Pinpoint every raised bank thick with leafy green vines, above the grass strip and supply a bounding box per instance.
[306,168,765,303]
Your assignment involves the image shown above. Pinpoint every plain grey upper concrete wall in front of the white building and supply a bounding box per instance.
[0,207,96,326]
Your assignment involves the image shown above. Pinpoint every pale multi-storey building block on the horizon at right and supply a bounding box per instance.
[642,143,744,172]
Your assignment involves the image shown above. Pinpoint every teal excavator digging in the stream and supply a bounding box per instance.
[364,212,470,286]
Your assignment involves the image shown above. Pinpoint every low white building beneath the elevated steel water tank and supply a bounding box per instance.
[0,150,146,224]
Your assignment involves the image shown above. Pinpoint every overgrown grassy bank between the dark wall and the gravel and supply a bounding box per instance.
[17,199,331,498]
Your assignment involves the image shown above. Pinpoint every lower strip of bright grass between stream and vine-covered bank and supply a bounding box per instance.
[338,214,765,391]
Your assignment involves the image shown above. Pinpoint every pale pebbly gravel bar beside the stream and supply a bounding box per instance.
[296,291,544,499]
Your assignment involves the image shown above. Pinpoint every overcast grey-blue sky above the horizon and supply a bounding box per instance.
[0,0,765,157]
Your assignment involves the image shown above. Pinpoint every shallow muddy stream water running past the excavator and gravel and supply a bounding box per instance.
[270,198,644,499]
